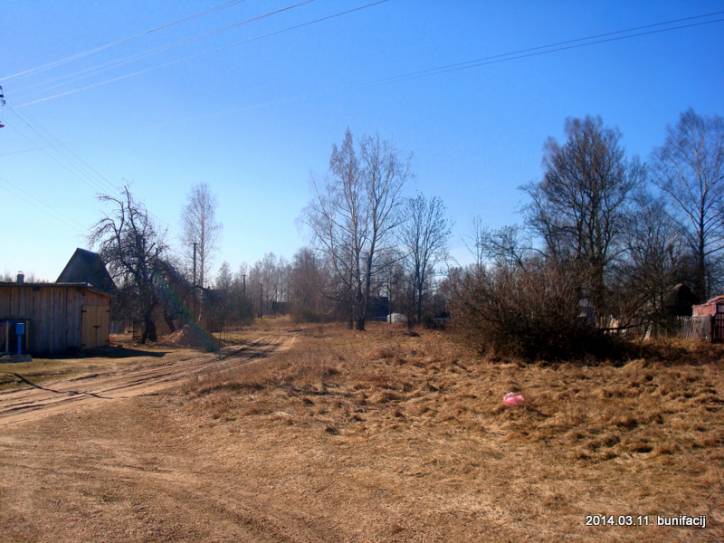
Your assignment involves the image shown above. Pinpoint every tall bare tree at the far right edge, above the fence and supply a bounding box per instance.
[653,109,724,300]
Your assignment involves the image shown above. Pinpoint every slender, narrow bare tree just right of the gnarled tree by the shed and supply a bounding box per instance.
[181,183,221,288]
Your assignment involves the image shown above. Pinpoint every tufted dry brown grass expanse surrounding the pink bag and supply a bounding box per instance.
[180,325,724,541]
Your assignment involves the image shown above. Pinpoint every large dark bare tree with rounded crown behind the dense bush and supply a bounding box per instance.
[525,117,644,317]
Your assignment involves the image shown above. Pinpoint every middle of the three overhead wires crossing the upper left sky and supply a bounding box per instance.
[15,0,316,100]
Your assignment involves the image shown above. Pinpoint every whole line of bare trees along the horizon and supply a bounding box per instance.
[85,110,724,346]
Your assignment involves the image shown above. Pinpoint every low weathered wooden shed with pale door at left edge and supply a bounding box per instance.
[0,275,111,355]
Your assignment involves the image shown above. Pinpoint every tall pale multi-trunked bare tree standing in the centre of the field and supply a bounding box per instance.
[306,130,409,330]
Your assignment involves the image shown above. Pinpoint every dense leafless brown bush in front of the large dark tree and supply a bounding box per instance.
[452,259,614,360]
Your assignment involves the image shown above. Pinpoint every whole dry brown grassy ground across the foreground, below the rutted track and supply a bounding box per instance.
[0,319,724,542]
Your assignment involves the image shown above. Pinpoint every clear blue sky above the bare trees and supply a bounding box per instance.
[0,0,724,280]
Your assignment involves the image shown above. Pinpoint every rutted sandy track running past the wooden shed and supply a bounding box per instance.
[0,335,294,427]
